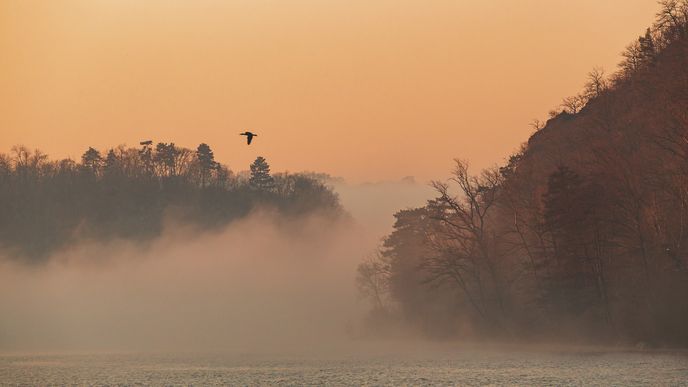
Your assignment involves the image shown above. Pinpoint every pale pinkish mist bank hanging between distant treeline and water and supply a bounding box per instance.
[0,182,426,353]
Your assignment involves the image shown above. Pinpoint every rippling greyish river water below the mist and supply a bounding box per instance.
[0,349,688,386]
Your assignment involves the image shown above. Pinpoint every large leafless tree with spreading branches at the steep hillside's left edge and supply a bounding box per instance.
[424,159,505,325]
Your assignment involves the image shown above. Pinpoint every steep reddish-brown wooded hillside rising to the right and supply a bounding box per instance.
[358,0,688,347]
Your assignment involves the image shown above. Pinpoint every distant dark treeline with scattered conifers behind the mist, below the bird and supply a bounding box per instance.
[0,141,341,261]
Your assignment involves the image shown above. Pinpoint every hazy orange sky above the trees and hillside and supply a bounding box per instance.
[0,0,657,181]
